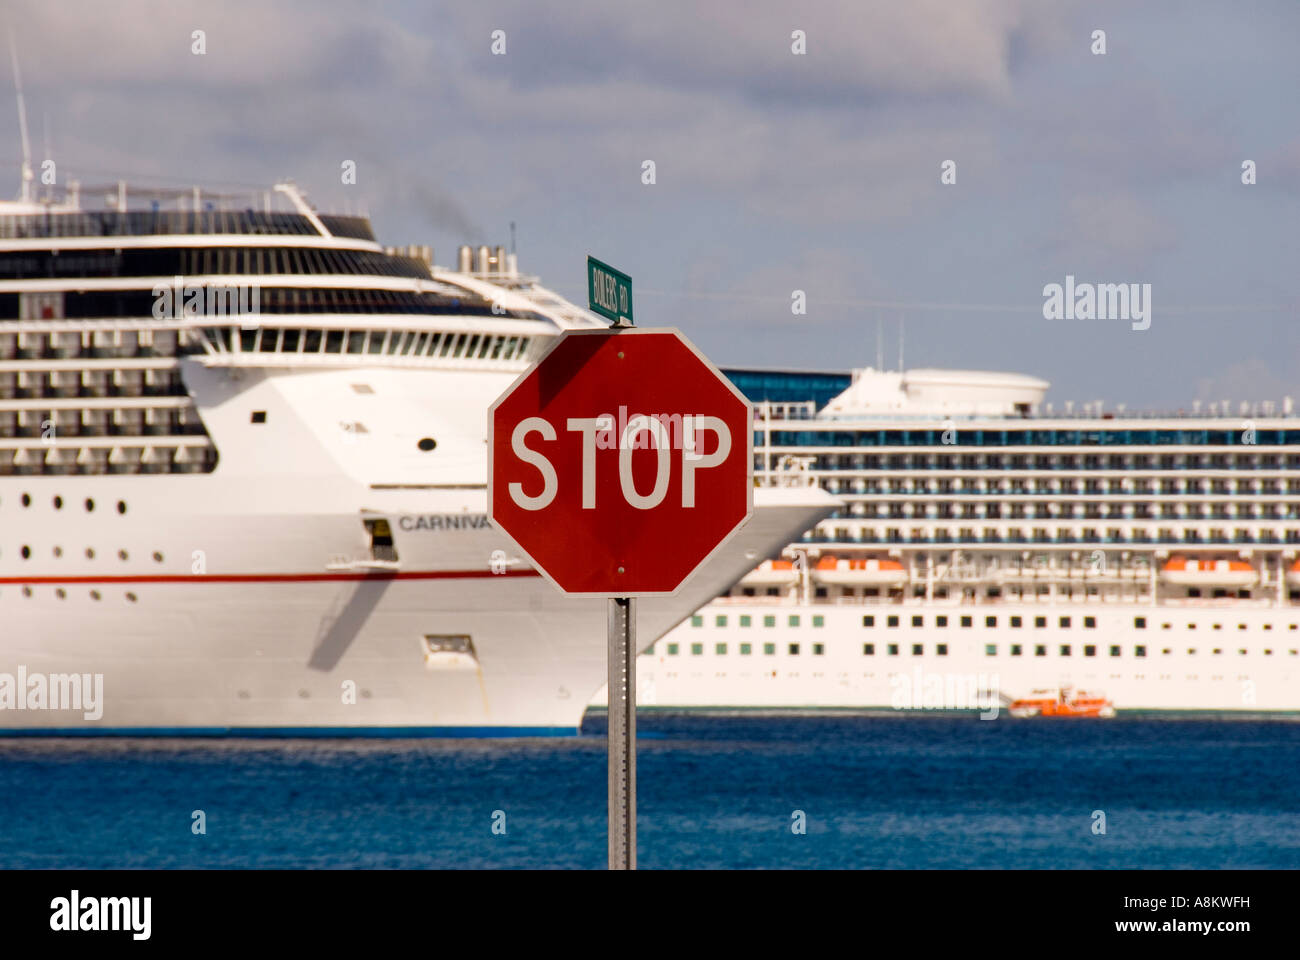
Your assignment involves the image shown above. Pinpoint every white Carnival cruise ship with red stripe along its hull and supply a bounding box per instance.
[0,178,835,735]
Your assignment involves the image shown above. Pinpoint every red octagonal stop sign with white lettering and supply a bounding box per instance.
[488,328,754,597]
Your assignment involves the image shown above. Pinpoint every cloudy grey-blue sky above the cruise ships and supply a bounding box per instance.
[0,0,1300,410]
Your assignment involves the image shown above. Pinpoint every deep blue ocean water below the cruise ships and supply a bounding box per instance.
[0,712,1300,869]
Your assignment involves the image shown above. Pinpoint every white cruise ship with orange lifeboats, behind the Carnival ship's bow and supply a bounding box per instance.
[618,369,1300,712]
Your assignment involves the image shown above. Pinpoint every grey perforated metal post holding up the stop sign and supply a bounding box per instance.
[608,597,637,870]
